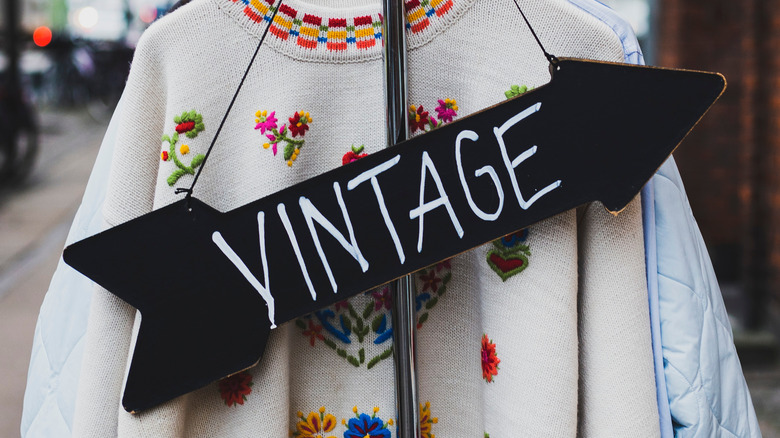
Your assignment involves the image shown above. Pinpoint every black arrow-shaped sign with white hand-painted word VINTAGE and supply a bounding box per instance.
[64,59,725,412]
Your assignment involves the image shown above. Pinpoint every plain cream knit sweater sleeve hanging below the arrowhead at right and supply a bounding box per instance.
[578,197,660,437]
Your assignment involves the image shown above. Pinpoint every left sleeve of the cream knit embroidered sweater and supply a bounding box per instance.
[73,26,165,437]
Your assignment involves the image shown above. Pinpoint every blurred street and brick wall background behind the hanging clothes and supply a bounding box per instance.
[0,0,780,438]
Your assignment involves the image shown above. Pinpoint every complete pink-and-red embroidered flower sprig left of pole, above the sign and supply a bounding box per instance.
[255,110,312,167]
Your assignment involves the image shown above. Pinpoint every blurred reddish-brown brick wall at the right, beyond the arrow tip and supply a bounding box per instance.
[657,0,780,328]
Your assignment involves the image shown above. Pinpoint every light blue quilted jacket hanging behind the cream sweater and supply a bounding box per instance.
[21,0,761,438]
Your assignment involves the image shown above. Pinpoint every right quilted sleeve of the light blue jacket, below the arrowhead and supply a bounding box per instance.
[653,160,761,437]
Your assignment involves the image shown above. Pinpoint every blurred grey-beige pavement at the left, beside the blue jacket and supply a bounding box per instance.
[0,110,107,437]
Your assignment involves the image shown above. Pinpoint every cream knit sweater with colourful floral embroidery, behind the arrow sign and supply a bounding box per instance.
[74,0,659,438]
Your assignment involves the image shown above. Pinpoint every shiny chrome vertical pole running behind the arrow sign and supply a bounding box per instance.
[384,0,420,438]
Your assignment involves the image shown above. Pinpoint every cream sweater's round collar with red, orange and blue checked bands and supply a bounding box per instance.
[213,0,475,63]
